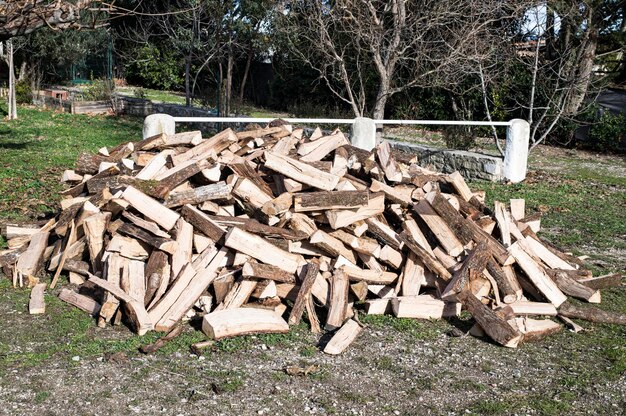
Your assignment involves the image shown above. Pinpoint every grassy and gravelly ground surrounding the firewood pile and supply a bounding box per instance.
[0,107,626,415]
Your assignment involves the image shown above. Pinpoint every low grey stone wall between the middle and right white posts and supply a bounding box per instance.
[389,140,504,182]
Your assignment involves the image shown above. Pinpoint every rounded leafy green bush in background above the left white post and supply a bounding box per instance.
[126,44,183,90]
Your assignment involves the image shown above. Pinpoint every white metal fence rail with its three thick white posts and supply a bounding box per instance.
[143,114,530,183]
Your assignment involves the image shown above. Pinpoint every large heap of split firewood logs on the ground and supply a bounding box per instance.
[0,120,626,354]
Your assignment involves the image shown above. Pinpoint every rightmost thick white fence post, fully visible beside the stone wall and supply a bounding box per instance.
[504,118,530,183]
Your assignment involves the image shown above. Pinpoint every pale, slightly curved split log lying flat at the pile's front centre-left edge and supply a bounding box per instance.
[202,308,289,341]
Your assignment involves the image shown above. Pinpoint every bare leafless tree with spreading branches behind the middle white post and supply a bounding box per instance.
[283,0,520,119]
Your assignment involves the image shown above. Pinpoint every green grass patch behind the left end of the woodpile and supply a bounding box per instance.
[0,106,142,221]
